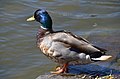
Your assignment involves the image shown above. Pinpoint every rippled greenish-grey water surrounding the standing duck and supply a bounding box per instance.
[0,0,120,79]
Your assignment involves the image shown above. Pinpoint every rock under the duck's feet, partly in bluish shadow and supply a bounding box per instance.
[36,64,120,79]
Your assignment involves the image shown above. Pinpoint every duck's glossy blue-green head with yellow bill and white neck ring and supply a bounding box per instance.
[27,9,52,30]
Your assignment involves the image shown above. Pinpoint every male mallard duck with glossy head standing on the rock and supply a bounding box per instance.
[27,9,112,74]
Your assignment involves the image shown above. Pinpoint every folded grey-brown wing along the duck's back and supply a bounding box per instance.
[53,31,106,54]
